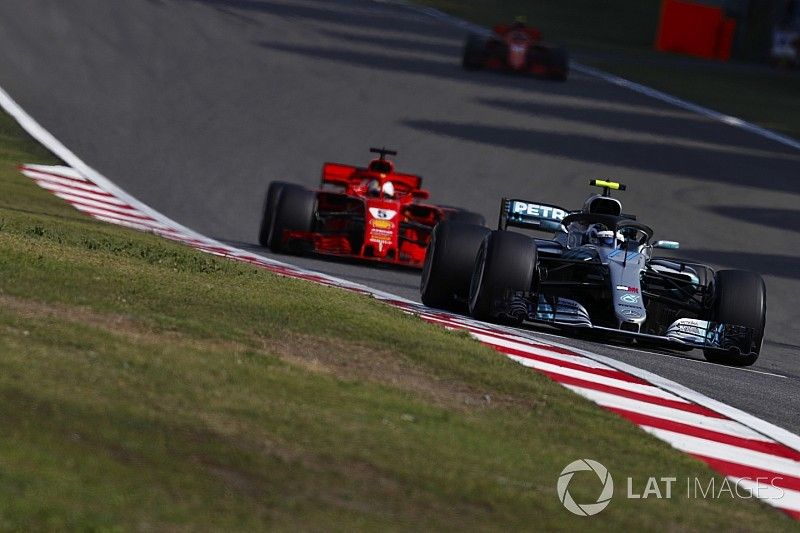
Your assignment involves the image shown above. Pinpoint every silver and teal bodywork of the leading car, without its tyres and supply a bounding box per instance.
[490,193,762,354]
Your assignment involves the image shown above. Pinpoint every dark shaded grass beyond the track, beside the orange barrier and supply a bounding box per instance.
[417,0,800,139]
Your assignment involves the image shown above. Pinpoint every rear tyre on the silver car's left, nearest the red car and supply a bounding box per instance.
[420,220,489,311]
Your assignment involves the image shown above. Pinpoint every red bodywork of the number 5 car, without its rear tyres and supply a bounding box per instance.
[282,159,455,268]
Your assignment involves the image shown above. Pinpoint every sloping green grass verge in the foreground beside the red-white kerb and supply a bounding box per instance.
[0,108,794,531]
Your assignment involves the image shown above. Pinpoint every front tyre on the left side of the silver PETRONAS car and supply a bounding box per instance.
[469,230,538,320]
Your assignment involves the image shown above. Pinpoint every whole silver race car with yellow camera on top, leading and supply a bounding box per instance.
[420,180,766,366]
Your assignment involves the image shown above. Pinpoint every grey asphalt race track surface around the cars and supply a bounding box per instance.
[0,0,800,433]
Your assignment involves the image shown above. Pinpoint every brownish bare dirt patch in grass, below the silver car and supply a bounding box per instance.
[262,334,531,410]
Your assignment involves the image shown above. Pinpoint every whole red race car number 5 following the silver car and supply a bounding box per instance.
[259,148,485,268]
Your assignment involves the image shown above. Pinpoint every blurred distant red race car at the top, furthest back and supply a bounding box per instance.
[462,22,569,81]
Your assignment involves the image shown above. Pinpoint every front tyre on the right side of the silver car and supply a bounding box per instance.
[703,270,767,366]
